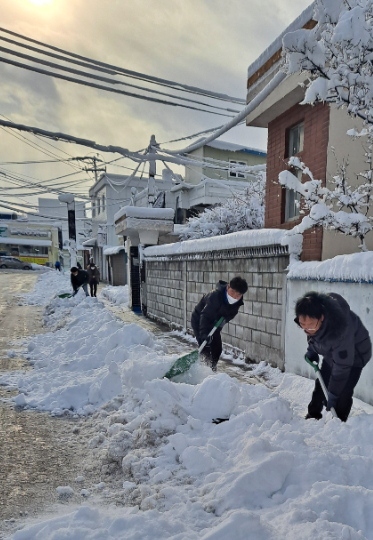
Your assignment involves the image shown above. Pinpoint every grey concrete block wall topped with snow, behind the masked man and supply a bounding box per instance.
[142,230,296,369]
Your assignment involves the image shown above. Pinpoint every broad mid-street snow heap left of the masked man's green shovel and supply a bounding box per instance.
[0,297,175,415]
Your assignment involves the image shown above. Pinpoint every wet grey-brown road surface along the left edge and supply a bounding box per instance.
[0,270,100,538]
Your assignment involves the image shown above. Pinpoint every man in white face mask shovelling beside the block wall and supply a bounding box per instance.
[191,277,247,371]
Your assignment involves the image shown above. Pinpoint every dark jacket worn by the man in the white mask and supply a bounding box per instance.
[191,281,243,343]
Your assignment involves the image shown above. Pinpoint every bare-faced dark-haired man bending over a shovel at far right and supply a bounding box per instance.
[295,292,372,422]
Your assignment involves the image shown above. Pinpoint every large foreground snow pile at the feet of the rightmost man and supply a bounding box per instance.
[9,374,373,540]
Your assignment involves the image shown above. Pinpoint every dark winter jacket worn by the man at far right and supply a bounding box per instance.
[296,293,372,396]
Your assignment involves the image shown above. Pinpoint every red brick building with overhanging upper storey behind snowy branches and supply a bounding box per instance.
[246,5,373,261]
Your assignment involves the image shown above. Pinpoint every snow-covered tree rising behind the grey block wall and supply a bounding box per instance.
[180,172,265,240]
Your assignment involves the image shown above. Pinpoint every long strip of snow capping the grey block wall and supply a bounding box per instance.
[144,229,303,257]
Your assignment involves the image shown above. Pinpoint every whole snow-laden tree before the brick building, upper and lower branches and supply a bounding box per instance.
[279,0,373,250]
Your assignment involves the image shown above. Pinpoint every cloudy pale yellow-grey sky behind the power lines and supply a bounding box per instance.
[0,0,310,214]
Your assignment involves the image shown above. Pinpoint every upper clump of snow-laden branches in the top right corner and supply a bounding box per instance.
[283,0,373,119]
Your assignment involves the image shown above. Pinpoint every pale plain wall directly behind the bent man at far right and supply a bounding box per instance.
[285,272,373,405]
